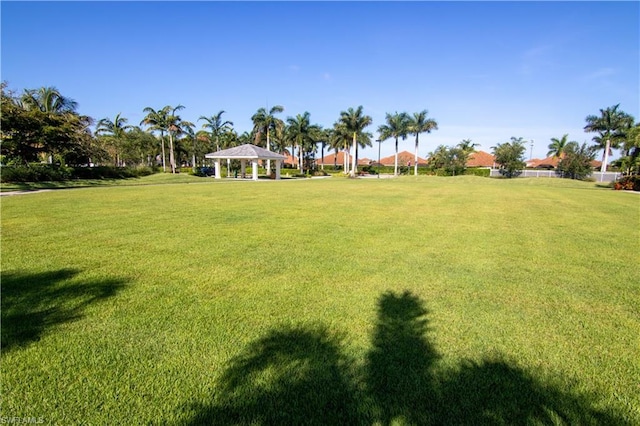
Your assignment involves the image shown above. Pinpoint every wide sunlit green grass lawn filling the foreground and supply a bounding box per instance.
[0,176,640,425]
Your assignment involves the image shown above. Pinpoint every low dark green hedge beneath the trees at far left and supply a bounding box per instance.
[0,164,155,183]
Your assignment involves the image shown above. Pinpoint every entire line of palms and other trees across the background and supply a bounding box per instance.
[0,82,640,178]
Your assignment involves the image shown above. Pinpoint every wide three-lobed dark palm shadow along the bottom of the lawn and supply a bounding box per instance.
[180,292,629,425]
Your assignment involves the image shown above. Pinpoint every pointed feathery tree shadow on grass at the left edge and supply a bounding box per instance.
[0,269,125,351]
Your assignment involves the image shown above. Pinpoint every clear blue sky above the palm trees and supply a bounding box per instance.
[0,1,640,159]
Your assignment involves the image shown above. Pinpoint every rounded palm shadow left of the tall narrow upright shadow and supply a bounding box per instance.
[189,327,358,425]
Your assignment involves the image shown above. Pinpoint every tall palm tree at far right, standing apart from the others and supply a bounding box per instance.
[584,104,634,172]
